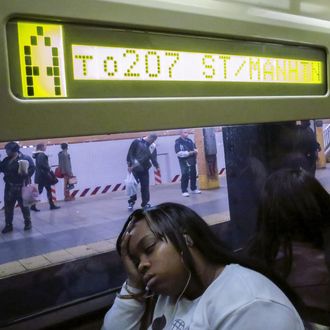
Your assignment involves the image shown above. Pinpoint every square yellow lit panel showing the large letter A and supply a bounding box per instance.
[17,22,67,98]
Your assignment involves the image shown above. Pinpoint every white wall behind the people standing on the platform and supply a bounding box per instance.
[0,132,225,204]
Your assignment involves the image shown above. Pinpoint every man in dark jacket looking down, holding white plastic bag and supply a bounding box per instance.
[126,134,159,210]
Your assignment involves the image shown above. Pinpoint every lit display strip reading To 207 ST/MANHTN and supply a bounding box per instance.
[72,45,322,84]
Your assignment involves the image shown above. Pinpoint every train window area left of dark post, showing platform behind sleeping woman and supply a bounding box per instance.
[0,127,229,328]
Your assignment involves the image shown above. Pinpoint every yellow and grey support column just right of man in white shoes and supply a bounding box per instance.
[194,128,220,190]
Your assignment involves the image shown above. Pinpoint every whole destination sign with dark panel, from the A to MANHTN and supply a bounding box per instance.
[7,20,326,98]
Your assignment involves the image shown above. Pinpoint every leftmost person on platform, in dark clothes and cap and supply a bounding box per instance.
[0,141,35,234]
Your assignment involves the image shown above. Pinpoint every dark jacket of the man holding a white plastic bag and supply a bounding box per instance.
[126,139,159,171]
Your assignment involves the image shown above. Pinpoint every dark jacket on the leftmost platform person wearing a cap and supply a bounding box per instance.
[0,152,35,184]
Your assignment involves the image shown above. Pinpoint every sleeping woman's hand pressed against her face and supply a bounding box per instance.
[120,231,145,290]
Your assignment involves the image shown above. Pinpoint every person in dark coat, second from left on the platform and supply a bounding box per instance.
[31,143,60,212]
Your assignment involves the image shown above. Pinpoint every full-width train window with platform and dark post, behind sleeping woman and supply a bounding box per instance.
[0,120,330,328]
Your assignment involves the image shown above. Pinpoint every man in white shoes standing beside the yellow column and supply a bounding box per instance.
[175,129,201,197]
